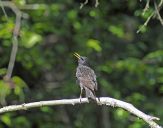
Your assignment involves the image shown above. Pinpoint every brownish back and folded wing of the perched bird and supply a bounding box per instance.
[76,66,97,90]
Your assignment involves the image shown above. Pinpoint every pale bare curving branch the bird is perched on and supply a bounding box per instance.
[0,97,162,128]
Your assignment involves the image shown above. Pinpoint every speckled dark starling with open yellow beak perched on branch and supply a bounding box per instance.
[74,53,97,102]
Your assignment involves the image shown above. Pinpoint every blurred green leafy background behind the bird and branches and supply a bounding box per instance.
[0,0,163,128]
